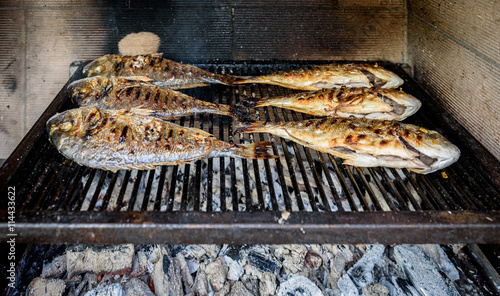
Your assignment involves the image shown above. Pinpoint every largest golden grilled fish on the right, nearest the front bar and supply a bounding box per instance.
[237,117,460,174]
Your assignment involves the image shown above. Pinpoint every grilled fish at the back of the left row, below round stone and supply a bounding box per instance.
[83,53,242,89]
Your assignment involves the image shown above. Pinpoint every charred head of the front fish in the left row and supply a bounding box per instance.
[46,107,104,147]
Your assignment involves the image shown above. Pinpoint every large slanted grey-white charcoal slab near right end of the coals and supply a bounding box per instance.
[394,245,459,295]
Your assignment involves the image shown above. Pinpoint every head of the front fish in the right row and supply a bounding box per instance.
[398,124,460,174]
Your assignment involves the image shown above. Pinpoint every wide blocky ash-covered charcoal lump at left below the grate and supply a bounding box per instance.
[66,244,134,278]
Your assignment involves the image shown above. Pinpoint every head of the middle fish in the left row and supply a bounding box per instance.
[68,76,113,106]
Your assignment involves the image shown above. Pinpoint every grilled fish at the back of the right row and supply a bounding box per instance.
[229,63,403,91]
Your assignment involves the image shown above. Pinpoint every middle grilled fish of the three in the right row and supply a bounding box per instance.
[243,88,422,120]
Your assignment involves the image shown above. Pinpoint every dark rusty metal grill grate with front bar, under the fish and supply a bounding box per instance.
[0,62,500,244]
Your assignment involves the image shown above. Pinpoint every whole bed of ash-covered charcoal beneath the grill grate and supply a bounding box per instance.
[31,244,482,296]
